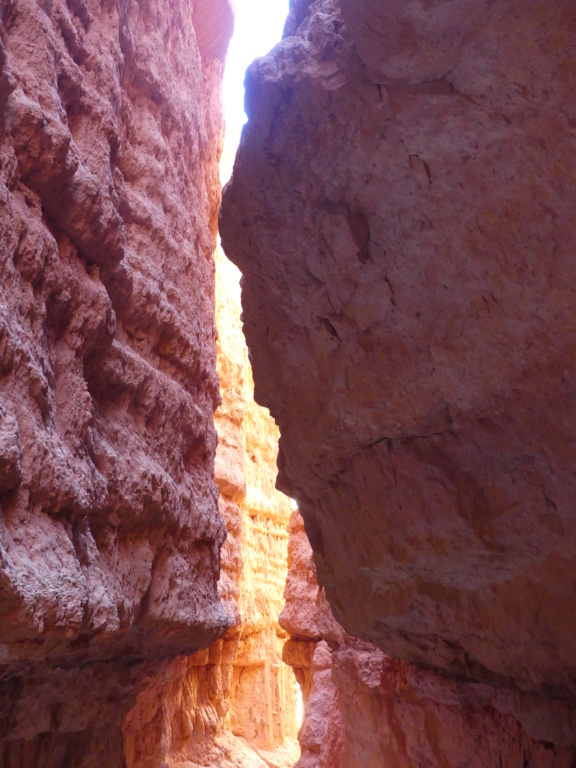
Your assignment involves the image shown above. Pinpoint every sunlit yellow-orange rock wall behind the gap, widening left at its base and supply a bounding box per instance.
[124,251,300,768]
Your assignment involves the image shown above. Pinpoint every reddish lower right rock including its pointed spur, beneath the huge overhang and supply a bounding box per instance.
[280,512,574,768]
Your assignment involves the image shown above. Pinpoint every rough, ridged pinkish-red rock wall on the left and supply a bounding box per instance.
[0,0,232,768]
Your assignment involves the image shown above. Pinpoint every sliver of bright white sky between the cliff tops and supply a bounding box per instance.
[220,0,288,183]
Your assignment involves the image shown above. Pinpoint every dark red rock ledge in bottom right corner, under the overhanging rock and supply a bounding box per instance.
[330,643,574,768]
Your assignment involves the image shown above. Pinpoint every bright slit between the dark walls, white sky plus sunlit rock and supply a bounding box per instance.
[208,0,303,768]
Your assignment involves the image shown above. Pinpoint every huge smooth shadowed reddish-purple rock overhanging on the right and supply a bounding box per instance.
[221,0,576,765]
